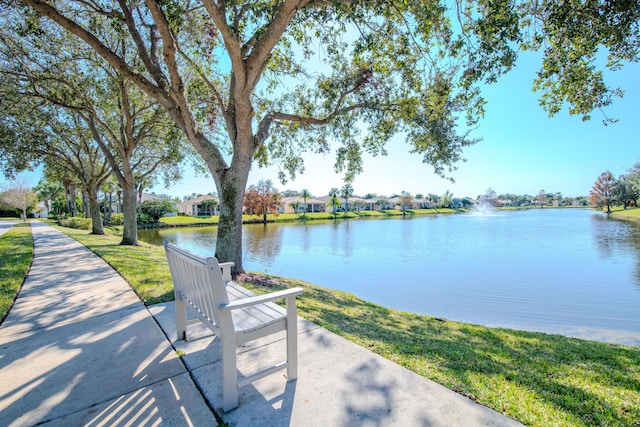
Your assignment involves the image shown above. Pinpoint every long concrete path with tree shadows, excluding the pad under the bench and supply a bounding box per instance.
[0,222,216,426]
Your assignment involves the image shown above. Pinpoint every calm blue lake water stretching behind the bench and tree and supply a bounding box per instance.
[140,209,640,345]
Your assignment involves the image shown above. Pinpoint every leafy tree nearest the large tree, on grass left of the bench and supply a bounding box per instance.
[0,21,183,245]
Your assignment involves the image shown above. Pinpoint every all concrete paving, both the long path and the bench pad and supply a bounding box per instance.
[0,222,519,426]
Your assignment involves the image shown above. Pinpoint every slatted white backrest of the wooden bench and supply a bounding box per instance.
[164,241,229,327]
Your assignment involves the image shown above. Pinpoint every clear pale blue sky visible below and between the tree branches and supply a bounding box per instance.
[6,54,640,202]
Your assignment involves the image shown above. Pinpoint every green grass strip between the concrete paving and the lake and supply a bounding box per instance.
[0,219,640,426]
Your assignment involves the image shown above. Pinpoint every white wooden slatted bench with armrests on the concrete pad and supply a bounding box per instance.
[164,241,303,412]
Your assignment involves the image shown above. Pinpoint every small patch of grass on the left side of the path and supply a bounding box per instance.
[0,223,33,322]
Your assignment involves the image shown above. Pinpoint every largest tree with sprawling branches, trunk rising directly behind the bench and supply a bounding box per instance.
[10,0,640,272]
